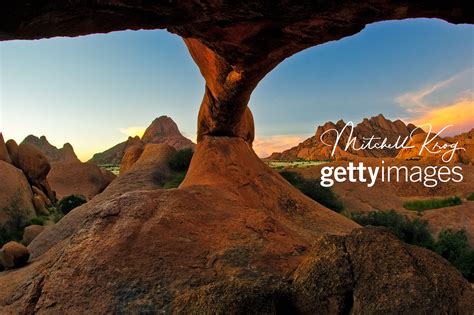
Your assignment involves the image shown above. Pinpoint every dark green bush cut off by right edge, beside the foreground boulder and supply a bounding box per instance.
[434,229,474,282]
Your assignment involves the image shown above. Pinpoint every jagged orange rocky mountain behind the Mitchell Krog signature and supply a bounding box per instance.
[269,114,422,160]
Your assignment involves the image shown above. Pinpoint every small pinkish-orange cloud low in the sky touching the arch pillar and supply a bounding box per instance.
[253,135,308,158]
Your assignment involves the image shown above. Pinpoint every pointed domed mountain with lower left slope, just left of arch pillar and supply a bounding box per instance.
[90,116,195,165]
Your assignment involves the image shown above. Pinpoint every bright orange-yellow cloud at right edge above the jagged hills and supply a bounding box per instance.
[412,98,474,135]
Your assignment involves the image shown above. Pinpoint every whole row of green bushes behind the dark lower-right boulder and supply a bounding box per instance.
[344,210,474,282]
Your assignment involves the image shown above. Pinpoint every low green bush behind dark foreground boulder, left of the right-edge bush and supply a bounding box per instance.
[350,210,434,249]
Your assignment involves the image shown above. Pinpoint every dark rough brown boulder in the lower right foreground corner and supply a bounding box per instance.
[294,227,474,314]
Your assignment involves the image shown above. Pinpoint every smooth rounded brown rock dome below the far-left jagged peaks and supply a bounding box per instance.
[48,161,115,199]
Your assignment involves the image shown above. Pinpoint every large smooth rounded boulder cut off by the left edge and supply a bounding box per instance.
[0,161,35,233]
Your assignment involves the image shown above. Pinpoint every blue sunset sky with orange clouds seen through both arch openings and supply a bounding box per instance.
[0,19,474,160]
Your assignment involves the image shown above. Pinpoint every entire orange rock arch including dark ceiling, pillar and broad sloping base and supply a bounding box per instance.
[0,0,474,314]
